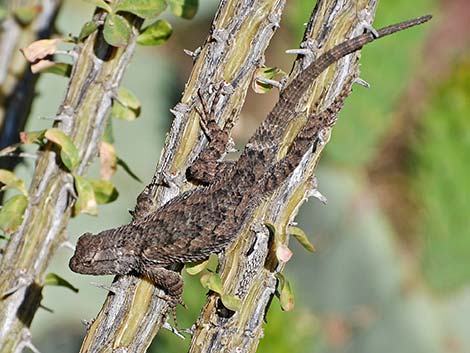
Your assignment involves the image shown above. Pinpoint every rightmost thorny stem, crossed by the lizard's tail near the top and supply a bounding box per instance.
[190,0,376,353]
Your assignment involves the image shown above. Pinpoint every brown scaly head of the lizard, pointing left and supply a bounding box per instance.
[69,231,136,275]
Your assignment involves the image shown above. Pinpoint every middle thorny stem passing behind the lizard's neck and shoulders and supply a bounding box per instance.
[81,0,285,353]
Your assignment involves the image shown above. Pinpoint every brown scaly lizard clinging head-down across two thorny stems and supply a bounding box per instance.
[69,15,431,308]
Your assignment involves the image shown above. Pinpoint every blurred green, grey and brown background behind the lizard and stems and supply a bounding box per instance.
[4,0,470,353]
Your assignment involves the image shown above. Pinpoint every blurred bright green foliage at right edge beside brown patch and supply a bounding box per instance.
[413,56,470,291]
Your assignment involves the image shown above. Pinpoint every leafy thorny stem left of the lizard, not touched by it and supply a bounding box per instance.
[0,9,142,353]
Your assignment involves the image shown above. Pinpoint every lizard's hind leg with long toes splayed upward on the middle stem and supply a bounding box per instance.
[188,84,235,184]
